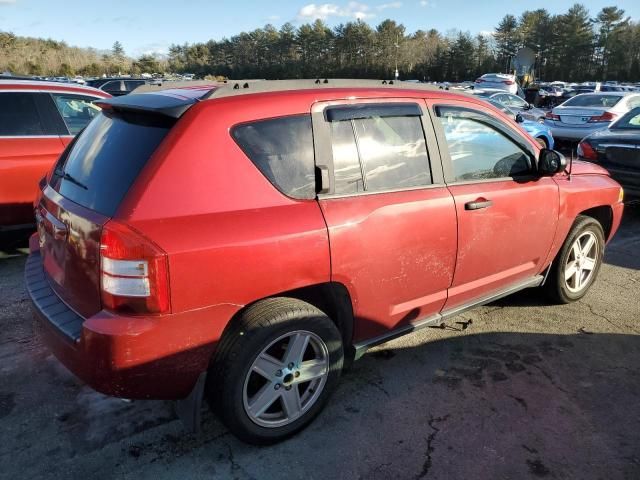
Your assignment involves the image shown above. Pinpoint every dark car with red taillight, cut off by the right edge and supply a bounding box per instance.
[578,107,640,198]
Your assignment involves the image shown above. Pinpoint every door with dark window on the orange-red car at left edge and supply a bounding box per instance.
[0,91,63,227]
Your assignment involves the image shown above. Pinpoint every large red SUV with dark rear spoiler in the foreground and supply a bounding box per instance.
[25,81,623,443]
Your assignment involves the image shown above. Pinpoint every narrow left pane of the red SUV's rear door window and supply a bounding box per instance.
[330,120,364,194]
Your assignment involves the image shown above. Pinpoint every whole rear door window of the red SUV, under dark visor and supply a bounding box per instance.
[331,105,432,194]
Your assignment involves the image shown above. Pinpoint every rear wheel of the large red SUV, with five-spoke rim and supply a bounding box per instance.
[207,298,344,445]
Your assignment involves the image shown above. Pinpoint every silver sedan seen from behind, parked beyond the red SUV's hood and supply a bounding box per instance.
[545,92,640,141]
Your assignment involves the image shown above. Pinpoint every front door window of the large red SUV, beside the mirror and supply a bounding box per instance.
[436,106,531,182]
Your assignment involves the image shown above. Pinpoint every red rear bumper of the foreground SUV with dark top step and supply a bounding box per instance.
[25,245,233,399]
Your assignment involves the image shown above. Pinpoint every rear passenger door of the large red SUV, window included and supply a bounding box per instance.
[312,99,456,341]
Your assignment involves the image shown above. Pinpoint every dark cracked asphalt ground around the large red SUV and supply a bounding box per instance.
[0,206,640,480]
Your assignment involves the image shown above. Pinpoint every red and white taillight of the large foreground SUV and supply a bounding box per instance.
[100,220,170,314]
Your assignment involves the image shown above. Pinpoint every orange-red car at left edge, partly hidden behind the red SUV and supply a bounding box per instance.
[0,79,109,243]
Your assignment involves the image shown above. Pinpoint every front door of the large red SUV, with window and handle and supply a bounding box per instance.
[427,100,559,310]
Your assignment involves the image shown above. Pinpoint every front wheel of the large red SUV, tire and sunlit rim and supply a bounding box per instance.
[544,215,605,303]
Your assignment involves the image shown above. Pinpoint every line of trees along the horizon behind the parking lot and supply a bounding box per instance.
[0,4,640,81]
